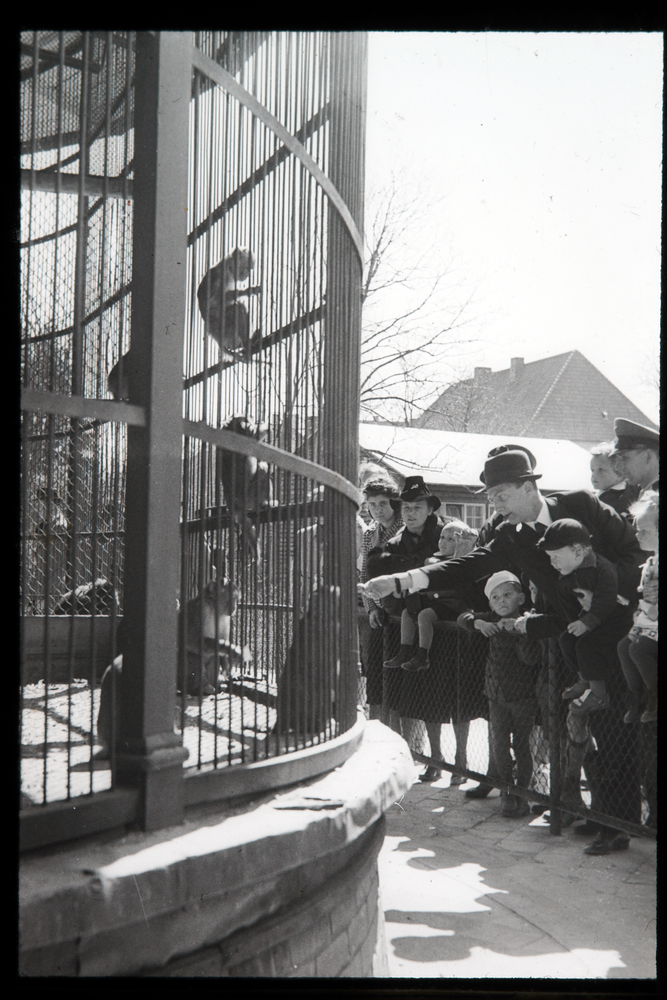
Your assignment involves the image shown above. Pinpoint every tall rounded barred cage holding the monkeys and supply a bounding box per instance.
[20,31,365,847]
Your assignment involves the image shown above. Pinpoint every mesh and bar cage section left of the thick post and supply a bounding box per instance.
[20,32,134,805]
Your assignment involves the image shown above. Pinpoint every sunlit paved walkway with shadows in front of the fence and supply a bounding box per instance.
[379,766,656,979]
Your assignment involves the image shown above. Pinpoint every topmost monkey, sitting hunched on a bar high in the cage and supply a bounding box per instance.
[197,247,259,361]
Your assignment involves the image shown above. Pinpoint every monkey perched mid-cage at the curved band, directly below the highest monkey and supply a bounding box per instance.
[216,416,273,560]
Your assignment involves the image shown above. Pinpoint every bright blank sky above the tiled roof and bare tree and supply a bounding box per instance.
[366,32,663,420]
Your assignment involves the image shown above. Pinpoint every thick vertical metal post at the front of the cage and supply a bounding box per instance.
[116,32,191,830]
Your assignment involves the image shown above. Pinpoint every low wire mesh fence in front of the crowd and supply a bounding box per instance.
[360,615,657,836]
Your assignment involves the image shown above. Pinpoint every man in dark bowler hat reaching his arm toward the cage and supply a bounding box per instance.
[366,449,643,854]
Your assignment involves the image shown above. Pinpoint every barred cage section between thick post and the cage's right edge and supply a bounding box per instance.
[176,32,356,768]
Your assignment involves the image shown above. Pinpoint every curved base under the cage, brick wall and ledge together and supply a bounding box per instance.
[19,721,415,978]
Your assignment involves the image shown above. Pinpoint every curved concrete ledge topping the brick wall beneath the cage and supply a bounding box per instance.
[20,722,414,976]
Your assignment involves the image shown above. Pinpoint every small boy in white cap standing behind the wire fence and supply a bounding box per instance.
[457,570,541,819]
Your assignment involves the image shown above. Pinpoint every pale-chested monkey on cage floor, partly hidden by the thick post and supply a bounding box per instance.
[95,578,252,760]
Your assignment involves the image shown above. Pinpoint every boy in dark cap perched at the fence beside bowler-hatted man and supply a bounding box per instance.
[537,517,618,714]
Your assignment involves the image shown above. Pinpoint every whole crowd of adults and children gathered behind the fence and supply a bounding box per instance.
[359,418,659,854]
